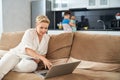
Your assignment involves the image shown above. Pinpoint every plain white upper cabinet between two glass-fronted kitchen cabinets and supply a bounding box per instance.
[69,0,88,9]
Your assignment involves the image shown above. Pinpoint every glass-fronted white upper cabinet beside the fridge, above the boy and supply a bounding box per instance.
[52,0,69,11]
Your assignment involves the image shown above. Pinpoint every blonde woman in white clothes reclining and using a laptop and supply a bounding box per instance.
[0,16,52,80]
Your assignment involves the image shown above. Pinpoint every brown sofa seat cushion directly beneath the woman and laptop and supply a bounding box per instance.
[3,72,92,80]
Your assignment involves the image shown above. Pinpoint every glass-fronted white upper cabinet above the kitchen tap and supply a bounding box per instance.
[87,0,109,9]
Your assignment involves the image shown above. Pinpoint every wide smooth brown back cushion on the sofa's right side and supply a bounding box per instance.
[71,32,120,63]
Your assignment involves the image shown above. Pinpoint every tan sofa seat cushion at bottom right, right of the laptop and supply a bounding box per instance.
[75,69,120,80]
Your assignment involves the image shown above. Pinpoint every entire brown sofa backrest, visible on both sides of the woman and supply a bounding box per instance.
[0,32,120,63]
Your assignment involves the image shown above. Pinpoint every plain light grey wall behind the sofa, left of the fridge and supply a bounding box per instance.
[2,0,31,32]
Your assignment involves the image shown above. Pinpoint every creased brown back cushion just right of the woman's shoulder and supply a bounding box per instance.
[47,33,73,59]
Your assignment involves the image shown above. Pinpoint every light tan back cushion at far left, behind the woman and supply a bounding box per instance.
[0,31,24,50]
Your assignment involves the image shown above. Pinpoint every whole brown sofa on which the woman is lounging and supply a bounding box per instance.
[0,31,120,80]
